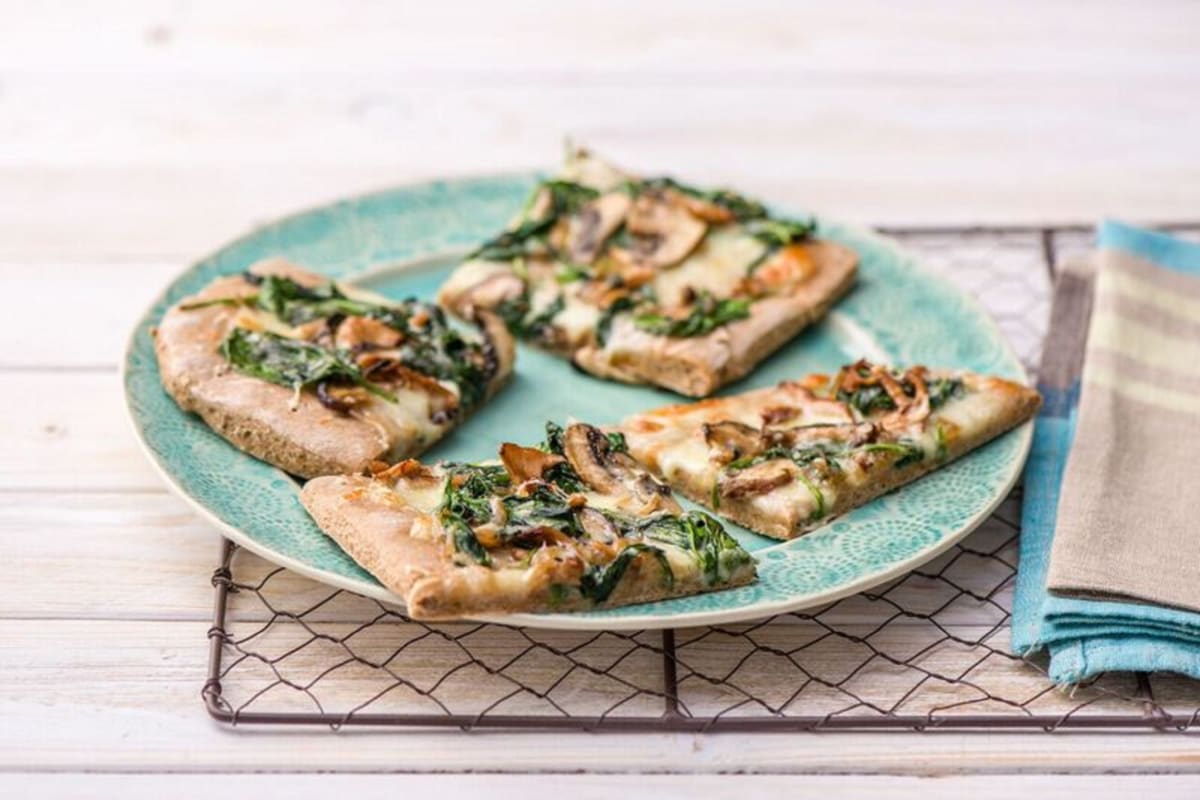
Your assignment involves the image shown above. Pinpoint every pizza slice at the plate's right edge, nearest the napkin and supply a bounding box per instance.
[619,361,1042,539]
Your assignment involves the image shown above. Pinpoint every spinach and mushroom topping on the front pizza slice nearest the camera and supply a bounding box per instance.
[393,423,752,603]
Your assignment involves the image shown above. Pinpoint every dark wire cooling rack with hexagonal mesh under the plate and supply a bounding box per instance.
[203,223,1200,732]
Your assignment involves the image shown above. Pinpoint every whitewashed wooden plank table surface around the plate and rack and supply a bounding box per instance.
[0,0,1200,796]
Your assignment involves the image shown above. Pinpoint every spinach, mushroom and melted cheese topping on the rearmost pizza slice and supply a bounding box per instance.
[450,155,835,349]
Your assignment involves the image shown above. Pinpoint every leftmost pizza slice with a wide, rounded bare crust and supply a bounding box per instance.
[154,259,514,477]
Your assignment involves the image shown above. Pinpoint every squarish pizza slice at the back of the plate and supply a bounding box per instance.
[438,150,858,397]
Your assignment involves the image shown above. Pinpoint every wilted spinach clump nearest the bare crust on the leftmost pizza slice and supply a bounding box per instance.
[221,327,396,403]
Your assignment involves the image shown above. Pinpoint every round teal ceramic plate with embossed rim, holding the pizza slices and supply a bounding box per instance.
[124,175,1032,630]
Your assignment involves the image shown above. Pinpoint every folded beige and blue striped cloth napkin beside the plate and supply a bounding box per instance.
[1013,222,1200,684]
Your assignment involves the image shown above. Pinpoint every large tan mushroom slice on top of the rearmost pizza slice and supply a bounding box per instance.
[610,190,708,269]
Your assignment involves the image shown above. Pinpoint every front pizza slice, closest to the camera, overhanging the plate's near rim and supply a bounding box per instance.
[300,423,755,619]
